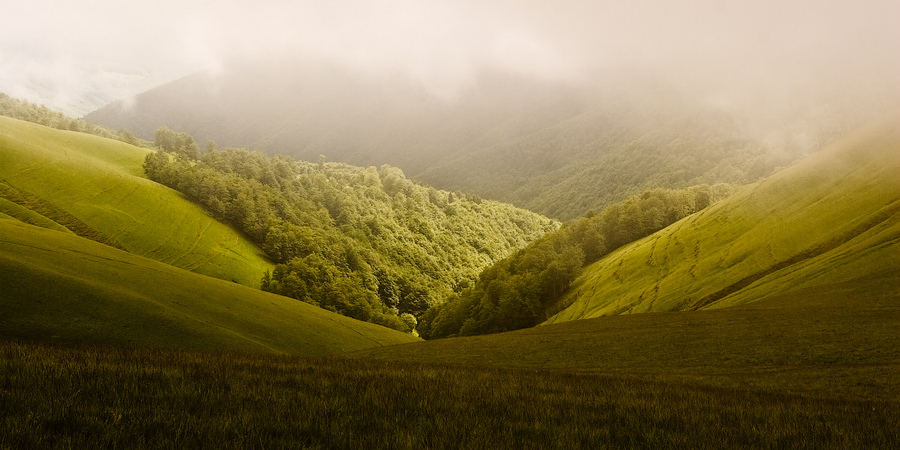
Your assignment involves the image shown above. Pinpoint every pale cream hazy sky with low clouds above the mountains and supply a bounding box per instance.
[0,0,900,115]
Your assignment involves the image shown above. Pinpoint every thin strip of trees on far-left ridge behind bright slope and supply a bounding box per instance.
[0,93,148,146]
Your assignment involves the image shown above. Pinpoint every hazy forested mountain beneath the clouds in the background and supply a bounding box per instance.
[87,62,856,219]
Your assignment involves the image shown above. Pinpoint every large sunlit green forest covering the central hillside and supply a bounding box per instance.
[144,139,558,330]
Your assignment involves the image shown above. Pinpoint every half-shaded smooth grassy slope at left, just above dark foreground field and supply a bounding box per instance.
[0,219,416,355]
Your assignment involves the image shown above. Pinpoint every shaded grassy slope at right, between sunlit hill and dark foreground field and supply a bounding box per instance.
[354,280,900,401]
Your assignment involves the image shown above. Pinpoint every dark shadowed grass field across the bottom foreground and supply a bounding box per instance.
[0,341,900,449]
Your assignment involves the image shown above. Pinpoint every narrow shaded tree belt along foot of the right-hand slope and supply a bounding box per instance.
[419,184,734,339]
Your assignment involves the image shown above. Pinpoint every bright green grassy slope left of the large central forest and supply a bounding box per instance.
[0,117,270,287]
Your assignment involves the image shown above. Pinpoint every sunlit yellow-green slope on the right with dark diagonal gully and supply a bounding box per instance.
[548,121,900,323]
